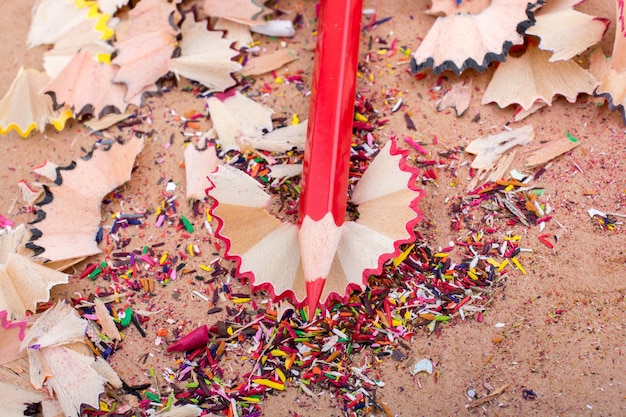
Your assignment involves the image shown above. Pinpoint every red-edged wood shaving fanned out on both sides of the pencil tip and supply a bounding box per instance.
[208,141,422,314]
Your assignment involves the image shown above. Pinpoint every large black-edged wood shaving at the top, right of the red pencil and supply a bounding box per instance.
[411,0,542,74]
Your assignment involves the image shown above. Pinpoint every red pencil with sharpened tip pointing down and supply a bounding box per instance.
[298,0,362,317]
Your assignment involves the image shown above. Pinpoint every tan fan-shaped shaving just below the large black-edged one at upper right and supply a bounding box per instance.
[482,45,598,110]
